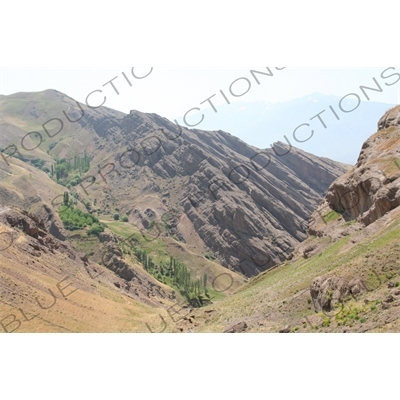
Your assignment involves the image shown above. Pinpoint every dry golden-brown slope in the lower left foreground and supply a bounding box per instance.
[0,207,176,332]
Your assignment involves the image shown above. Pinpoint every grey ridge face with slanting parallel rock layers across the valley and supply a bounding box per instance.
[104,111,345,276]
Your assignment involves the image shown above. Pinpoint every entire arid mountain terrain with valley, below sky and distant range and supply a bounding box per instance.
[0,90,400,332]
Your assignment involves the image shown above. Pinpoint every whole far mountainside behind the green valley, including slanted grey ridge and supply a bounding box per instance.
[0,90,345,276]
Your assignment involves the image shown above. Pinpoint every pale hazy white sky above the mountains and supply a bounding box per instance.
[0,67,400,119]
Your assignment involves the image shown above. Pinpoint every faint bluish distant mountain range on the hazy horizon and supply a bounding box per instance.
[178,93,394,164]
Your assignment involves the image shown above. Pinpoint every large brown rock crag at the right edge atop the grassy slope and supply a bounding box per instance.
[326,106,400,225]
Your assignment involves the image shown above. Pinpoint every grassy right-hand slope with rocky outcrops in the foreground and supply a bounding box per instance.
[188,106,400,332]
